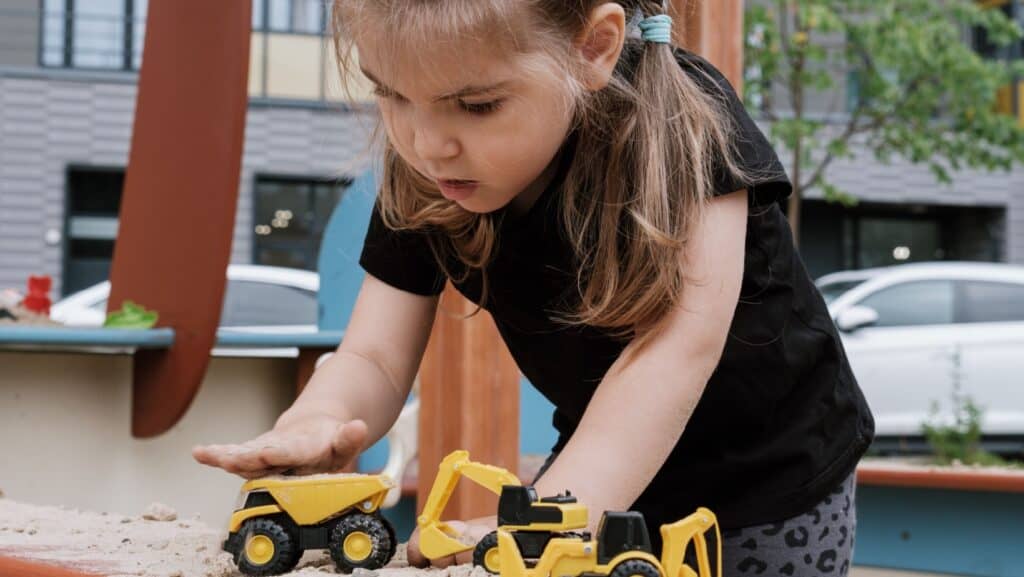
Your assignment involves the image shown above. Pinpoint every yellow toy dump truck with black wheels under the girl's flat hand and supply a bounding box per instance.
[223,475,397,576]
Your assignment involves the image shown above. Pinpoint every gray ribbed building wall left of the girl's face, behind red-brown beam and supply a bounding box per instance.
[0,69,369,294]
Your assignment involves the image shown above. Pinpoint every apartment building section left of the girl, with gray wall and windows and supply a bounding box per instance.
[0,0,372,294]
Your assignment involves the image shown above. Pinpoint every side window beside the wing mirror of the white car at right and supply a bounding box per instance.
[858,281,953,327]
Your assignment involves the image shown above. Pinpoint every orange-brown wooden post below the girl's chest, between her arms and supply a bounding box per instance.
[417,285,519,520]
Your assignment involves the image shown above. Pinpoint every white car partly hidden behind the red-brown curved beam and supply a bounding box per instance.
[50,264,319,357]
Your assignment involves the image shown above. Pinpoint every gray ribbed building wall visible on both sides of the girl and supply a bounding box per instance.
[0,62,1024,294]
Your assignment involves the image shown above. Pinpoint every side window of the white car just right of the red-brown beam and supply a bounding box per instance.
[220,281,317,327]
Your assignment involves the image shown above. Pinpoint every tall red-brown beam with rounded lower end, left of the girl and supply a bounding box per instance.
[108,0,252,438]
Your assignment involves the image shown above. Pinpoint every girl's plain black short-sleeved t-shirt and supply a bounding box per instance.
[359,50,873,541]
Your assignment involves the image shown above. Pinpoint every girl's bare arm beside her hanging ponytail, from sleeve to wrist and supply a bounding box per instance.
[537,190,748,529]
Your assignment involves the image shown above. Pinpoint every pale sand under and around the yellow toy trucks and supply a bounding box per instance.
[0,497,487,577]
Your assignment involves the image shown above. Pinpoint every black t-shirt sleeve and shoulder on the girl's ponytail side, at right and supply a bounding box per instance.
[676,49,793,206]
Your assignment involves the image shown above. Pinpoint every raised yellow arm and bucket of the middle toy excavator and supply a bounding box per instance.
[416,451,522,560]
